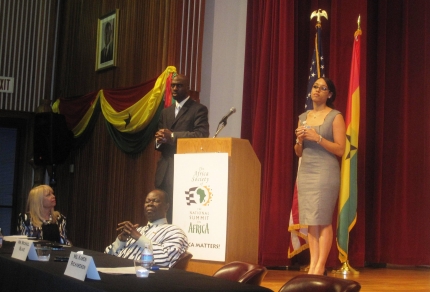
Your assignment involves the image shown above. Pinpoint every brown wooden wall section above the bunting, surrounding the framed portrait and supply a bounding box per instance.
[56,0,204,97]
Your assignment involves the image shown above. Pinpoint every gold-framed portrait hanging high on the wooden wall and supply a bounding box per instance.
[96,9,119,71]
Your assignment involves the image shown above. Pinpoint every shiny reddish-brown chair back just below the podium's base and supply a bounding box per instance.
[213,261,267,285]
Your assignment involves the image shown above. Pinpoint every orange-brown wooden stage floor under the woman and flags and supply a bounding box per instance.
[261,265,430,292]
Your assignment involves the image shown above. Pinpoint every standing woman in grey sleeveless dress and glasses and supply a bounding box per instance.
[294,77,346,275]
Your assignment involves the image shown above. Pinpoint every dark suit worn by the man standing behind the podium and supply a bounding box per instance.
[155,98,209,192]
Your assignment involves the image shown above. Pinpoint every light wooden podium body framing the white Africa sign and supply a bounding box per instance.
[176,138,261,275]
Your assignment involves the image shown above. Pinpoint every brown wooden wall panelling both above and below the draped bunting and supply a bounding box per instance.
[50,0,204,251]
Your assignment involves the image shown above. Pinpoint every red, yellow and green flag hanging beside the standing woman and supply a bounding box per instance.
[337,29,361,263]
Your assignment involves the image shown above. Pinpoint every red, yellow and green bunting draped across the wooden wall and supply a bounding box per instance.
[52,66,176,154]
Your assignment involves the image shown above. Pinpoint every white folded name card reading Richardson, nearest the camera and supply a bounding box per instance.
[64,251,100,281]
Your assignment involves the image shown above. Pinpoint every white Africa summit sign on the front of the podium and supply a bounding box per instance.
[173,153,228,262]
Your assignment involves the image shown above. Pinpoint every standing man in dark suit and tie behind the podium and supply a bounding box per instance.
[155,73,209,223]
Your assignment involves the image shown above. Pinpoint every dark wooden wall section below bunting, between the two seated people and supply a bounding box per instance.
[55,115,159,251]
